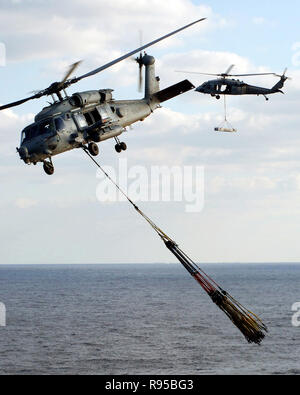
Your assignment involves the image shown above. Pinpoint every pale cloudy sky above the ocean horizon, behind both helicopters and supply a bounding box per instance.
[0,0,300,264]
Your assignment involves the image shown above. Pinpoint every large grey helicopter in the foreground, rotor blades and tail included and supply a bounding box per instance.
[0,18,206,175]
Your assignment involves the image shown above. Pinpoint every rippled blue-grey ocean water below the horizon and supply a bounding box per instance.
[0,264,300,375]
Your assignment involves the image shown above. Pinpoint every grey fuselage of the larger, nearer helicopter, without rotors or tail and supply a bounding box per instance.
[17,90,159,164]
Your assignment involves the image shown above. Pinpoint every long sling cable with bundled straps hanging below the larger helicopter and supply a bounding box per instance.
[83,147,268,344]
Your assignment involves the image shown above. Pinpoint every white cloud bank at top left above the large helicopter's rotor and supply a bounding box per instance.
[0,0,218,64]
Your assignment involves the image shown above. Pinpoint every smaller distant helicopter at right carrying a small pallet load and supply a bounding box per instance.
[178,65,290,100]
